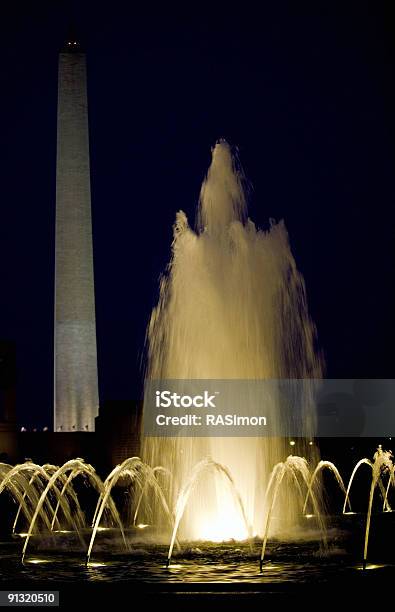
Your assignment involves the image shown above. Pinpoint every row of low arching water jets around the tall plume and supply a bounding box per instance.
[0,447,395,570]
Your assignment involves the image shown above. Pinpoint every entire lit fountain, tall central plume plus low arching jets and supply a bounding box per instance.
[0,141,395,580]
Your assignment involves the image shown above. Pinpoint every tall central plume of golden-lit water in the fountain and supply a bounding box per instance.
[143,141,322,540]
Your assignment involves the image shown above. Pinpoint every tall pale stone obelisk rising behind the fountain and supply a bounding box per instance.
[54,35,99,431]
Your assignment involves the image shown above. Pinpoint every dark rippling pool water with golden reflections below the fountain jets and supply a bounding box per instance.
[0,541,395,587]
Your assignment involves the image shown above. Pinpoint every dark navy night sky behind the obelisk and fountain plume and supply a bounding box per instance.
[0,0,395,426]
